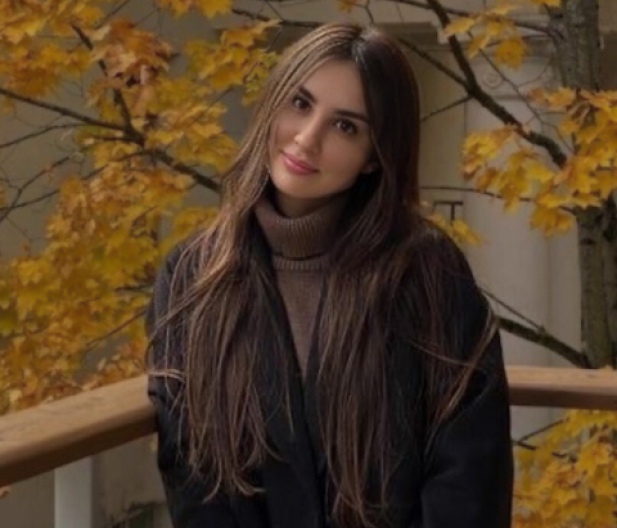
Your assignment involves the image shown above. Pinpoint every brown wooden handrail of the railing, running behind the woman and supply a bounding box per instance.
[0,366,617,487]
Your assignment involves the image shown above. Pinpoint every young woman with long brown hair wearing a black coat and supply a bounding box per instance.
[147,24,512,528]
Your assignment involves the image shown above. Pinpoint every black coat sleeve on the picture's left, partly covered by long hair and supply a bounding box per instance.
[146,244,237,528]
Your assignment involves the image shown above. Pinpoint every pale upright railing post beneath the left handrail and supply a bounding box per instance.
[54,457,102,528]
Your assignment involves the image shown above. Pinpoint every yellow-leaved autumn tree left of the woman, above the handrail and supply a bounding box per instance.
[0,0,277,413]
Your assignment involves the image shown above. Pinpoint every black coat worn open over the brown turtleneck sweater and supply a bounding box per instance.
[147,231,513,528]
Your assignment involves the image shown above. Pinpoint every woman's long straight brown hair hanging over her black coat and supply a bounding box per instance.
[152,24,498,528]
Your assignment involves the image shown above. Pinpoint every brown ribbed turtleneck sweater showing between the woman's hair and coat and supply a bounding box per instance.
[255,195,346,377]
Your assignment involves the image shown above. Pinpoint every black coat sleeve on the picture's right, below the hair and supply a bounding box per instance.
[418,281,513,528]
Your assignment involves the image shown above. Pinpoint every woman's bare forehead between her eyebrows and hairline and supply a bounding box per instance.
[302,60,366,113]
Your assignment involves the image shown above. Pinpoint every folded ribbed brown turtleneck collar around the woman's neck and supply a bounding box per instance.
[255,194,347,260]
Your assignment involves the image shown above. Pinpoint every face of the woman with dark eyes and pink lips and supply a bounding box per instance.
[269,60,375,217]
